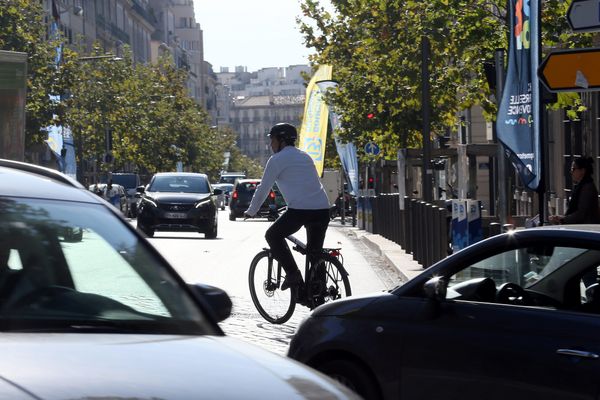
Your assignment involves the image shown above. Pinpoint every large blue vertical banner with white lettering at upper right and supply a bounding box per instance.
[496,0,542,190]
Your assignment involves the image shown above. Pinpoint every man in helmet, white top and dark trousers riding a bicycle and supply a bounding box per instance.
[244,123,329,300]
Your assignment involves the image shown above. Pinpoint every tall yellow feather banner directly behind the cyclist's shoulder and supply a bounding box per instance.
[298,65,332,176]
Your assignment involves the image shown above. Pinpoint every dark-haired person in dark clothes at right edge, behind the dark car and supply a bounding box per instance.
[548,157,600,224]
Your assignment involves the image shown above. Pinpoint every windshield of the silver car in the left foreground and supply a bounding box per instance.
[0,198,213,334]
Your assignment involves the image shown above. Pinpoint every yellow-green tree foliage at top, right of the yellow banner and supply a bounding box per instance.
[298,0,589,158]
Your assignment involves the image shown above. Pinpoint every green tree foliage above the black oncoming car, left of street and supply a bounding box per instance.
[65,48,224,177]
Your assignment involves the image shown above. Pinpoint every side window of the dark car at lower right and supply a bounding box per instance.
[447,245,600,310]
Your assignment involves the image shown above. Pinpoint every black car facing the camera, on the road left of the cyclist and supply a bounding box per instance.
[137,172,221,239]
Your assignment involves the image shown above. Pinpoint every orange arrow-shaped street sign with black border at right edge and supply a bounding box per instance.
[538,48,600,92]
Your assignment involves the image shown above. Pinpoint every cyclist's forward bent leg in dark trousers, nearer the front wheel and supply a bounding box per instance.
[265,209,303,282]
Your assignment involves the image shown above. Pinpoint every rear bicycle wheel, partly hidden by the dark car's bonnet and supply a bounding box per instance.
[307,254,352,309]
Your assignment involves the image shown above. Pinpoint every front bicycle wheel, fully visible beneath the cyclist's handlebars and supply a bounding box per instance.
[248,250,297,324]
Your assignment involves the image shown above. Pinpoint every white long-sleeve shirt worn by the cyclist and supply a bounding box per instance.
[246,146,329,215]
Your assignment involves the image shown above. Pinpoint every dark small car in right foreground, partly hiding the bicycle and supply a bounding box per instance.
[289,225,600,399]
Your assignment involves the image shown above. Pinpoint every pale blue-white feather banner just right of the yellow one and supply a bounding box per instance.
[317,80,358,196]
